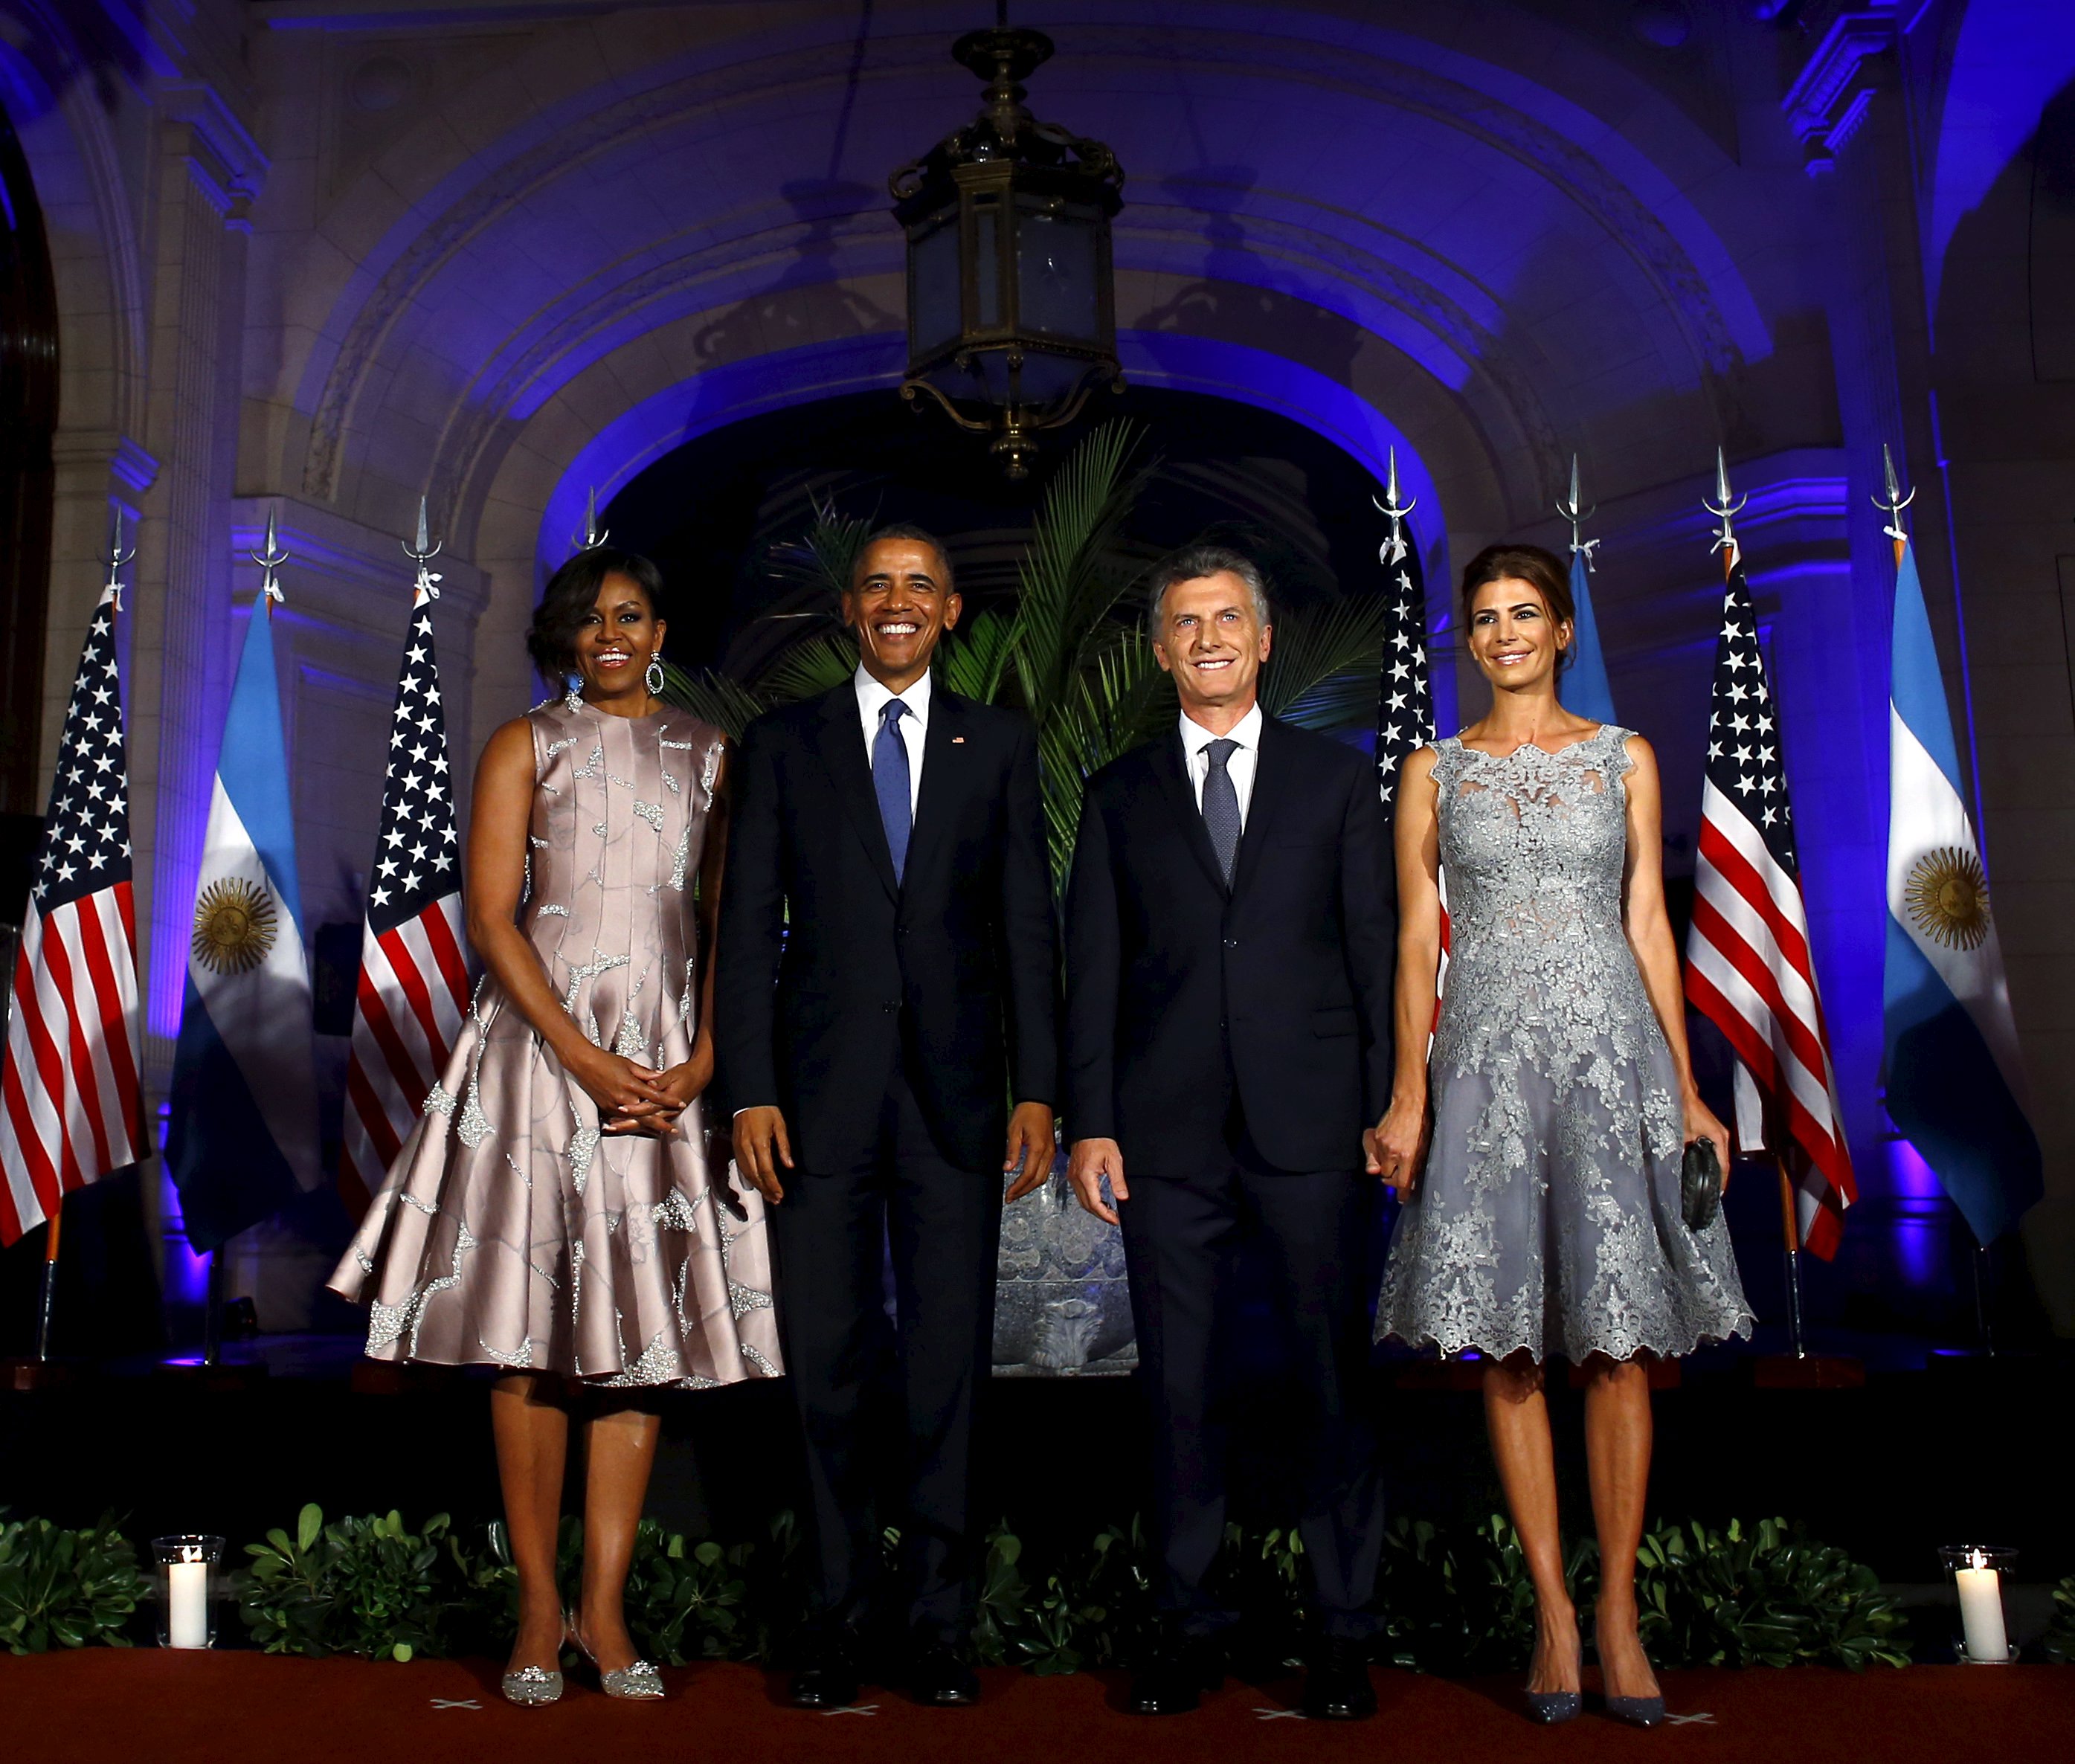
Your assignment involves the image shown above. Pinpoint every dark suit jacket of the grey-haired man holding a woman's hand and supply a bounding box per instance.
[1064,718,1397,1176]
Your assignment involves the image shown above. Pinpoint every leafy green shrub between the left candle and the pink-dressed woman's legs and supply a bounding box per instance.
[239,1502,483,1660]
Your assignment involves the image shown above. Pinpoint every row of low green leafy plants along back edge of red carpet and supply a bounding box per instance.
[0,1504,1917,1673]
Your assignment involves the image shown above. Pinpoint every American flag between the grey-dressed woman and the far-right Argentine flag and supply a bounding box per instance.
[1685,531,1857,1260]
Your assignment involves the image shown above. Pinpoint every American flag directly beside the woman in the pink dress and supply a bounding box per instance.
[338,547,469,1210]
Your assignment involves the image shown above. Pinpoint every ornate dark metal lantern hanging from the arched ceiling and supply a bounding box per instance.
[886,25,1125,477]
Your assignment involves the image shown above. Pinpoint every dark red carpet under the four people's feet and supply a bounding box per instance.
[0,1648,2075,1764]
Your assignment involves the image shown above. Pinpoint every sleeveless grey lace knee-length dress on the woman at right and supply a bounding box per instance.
[1376,724,1754,1365]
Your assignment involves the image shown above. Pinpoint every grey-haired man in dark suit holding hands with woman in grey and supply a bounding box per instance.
[1064,546,1397,1719]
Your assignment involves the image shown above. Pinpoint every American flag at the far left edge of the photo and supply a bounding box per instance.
[0,573,147,1245]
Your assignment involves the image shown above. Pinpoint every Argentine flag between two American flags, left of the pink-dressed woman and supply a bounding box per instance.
[166,568,321,1249]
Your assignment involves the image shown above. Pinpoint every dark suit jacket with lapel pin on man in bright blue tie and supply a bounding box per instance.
[714,680,1058,1171]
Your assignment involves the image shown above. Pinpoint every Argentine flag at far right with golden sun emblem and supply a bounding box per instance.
[1884,544,2042,1243]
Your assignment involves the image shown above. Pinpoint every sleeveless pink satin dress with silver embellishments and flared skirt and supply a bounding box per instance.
[332,698,780,1391]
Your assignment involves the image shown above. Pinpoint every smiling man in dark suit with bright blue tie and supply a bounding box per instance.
[714,527,1058,1708]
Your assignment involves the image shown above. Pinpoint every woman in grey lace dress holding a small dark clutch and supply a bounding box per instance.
[1369,546,1751,1725]
